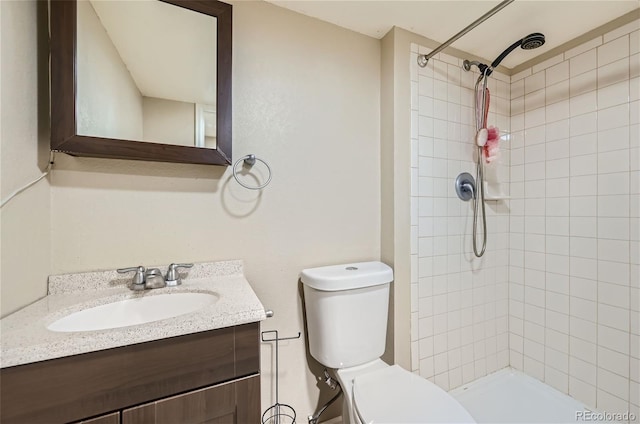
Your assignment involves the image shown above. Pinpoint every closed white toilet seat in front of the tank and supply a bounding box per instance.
[353,365,475,424]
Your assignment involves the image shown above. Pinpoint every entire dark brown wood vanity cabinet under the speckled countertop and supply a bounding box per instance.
[0,322,260,424]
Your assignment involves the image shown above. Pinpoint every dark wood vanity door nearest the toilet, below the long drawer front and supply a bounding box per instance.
[122,375,260,424]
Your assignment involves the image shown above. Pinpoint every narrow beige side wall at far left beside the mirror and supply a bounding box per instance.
[0,1,50,316]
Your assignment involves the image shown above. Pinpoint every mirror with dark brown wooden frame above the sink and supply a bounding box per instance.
[49,0,232,165]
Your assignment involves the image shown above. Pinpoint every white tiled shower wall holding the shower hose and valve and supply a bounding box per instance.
[411,45,509,390]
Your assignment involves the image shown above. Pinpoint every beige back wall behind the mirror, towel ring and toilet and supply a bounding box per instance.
[51,1,380,417]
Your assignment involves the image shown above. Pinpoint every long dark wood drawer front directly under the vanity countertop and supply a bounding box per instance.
[0,323,260,424]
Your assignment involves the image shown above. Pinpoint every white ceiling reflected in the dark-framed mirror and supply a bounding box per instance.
[90,0,217,105]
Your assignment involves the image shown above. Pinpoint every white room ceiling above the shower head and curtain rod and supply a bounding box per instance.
[267,0,640,68]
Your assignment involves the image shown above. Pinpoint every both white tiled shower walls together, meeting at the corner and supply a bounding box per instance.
[411,21,640,416]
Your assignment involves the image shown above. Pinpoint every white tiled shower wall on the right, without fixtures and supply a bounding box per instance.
[509,21,640,416]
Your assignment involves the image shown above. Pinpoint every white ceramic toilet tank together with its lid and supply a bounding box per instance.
[300,262,393,368]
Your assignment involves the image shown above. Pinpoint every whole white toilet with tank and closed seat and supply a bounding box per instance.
[300,262,475,424]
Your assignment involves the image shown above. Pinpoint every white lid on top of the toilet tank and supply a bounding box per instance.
[300,262,393,291]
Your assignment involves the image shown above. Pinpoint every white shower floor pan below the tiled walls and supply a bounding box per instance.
[449,368,612,424]
